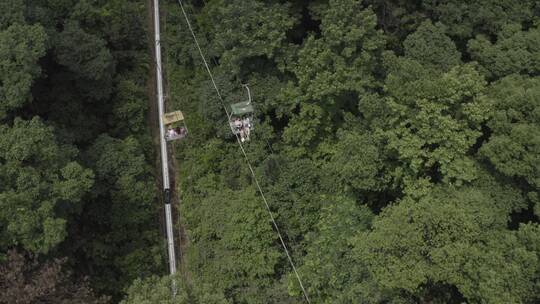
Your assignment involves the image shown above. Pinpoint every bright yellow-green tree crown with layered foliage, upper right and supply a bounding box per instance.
[384,56,489,184]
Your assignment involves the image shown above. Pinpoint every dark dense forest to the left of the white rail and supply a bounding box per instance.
[0,0,162,304]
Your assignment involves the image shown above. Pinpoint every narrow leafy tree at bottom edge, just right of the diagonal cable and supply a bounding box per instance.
[290,197,391,303]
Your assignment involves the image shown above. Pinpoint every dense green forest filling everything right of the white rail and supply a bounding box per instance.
[165,0,540,304]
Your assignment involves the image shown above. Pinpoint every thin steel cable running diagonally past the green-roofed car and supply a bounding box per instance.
[178,0,311,304]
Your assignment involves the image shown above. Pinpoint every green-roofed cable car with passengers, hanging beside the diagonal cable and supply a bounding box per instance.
[229,84,253,142]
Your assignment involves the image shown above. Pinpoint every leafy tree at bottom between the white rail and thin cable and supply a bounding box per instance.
[183,187,285,303]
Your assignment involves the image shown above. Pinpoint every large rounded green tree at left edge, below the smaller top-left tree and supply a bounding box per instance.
[0,117,94,253]
